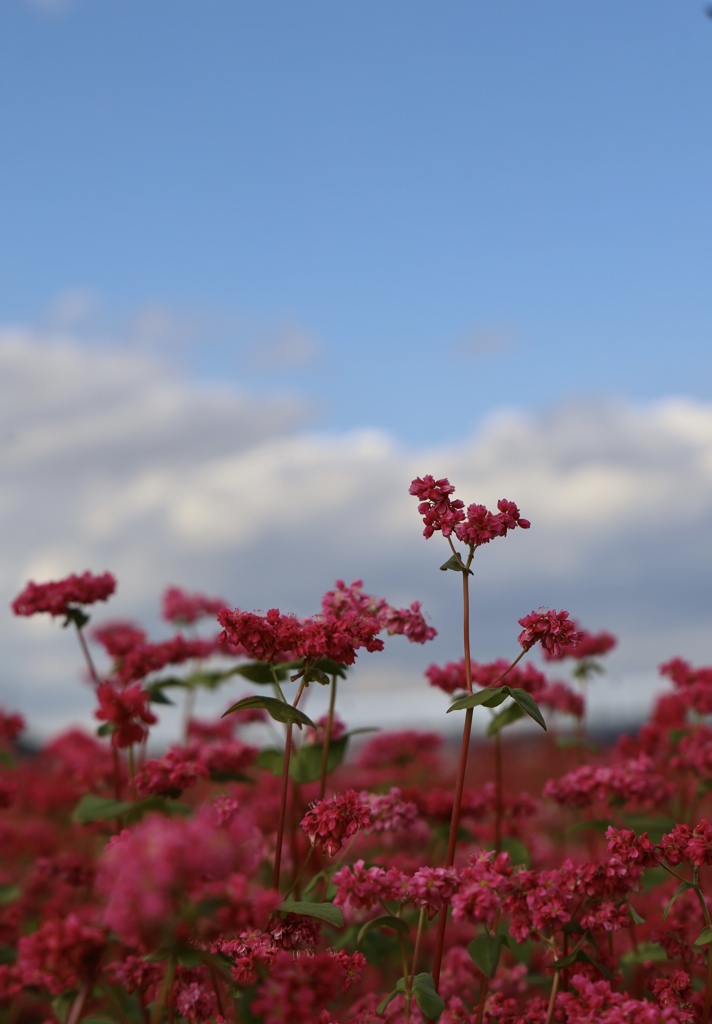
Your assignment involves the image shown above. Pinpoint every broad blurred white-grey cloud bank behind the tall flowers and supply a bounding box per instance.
[0,330,712,745]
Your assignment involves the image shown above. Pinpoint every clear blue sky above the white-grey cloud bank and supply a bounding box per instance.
[0,0,712,443]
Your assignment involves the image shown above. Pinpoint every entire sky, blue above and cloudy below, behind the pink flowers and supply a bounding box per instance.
[0,0,712,737]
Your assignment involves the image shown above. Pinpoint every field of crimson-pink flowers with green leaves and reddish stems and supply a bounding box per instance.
[0,476,712,1024]
